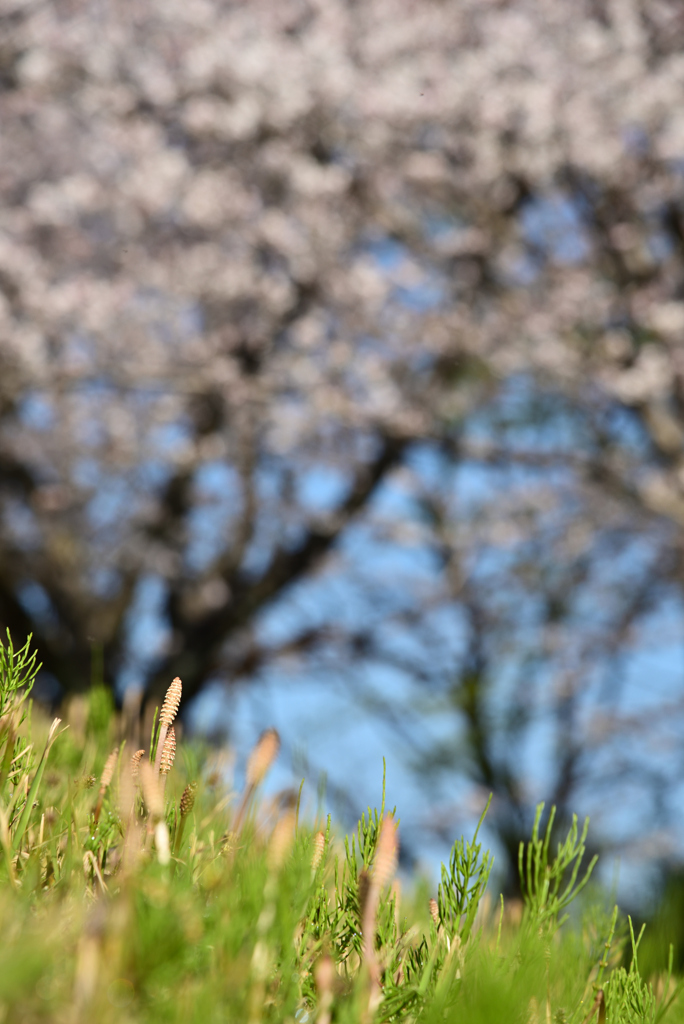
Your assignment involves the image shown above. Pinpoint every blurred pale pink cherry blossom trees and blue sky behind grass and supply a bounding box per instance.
[0,0,684,898]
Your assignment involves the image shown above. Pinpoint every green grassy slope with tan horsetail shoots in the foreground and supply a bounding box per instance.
[0,638,684,1024]
